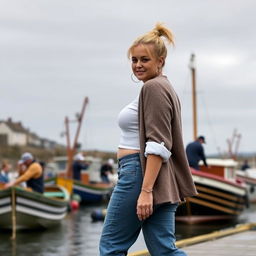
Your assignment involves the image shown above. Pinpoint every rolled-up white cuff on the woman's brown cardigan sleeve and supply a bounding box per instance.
[144,141,172,162]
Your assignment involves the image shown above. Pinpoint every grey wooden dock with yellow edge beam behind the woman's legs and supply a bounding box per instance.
[128,223,256,256]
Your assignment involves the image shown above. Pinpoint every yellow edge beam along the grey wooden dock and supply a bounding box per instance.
[128,223,256,256]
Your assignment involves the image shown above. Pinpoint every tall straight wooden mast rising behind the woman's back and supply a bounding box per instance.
[189,53,197,140]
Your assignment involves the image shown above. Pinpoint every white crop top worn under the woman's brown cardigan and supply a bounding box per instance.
[118,96,140,150]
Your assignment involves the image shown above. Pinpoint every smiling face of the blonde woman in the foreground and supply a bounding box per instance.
[131,44,163,83]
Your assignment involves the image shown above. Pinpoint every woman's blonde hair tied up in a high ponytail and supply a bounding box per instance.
[127,23,174,66]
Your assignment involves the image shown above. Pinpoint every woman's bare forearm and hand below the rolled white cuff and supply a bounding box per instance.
[137,155,163,221]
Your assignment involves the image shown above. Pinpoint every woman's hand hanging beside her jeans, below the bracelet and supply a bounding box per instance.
[137,190,153,221]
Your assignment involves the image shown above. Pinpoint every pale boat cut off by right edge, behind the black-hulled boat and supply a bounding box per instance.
[236,168,256,203]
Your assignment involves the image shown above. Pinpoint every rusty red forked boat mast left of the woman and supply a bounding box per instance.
[65,97,89,178]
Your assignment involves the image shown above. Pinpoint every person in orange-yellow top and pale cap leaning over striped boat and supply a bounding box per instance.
[5,152,44,193]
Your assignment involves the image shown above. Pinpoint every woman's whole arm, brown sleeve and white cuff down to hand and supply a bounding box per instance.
[137,79,173,220]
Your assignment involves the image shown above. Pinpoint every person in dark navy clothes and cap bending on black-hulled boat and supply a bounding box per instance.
[186,136,208,170]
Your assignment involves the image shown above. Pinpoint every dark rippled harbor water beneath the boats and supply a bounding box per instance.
[0,205,256,256]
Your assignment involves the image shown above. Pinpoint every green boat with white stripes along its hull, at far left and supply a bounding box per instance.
[0,185,69,229]
